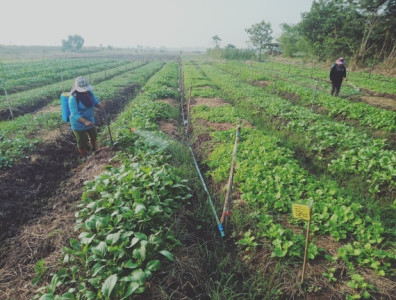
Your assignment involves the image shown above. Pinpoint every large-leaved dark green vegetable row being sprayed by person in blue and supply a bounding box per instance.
[36,63,191,299]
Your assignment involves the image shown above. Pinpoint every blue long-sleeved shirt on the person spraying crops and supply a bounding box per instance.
[69,92,99,131]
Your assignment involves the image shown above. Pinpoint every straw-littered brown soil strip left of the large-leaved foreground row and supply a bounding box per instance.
[0,148,114,299]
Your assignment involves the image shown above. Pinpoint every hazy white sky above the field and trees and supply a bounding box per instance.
[0,0,313,48]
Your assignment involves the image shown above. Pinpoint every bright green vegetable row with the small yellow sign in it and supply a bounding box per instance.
[184,66,395,293]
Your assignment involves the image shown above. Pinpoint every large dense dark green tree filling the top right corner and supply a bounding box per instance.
[298,0,396,67]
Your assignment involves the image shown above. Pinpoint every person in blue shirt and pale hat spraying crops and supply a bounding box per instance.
[69,76,104,157]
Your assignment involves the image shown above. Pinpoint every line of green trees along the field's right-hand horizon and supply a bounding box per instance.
[209,0,396,67]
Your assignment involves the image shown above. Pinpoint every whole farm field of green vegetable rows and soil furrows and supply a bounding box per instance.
[0,49,396,299]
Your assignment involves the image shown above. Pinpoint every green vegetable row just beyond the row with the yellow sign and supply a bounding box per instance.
[196,64,396,195]
